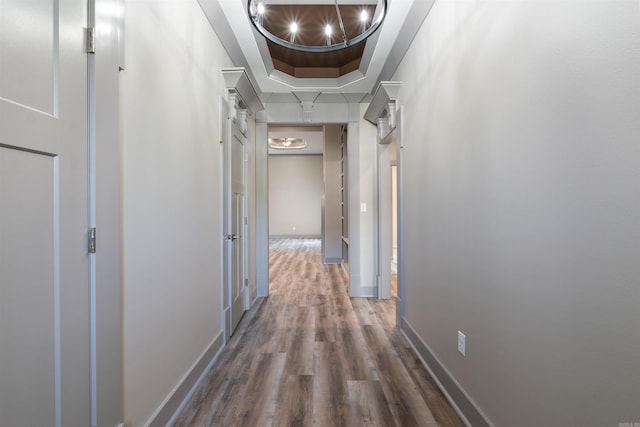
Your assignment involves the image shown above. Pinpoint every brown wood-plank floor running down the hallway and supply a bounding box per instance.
[175,239,463,427]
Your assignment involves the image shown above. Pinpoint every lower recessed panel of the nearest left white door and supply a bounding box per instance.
[0,147,60,426]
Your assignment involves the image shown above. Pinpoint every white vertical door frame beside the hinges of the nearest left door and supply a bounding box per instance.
[88,0,124,426]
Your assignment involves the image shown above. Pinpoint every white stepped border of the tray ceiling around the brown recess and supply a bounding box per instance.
[198,0,435,103]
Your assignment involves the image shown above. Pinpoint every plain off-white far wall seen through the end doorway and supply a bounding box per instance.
[269,154,323,238]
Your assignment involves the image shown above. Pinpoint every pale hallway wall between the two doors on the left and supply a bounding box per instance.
[120,0,232,427]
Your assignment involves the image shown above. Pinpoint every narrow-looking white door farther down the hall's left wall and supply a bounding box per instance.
[225,110,247,336]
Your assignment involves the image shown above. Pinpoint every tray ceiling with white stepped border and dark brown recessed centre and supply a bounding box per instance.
[198,0,434,102]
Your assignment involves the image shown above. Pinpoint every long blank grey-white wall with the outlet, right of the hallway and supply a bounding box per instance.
[393,0,640,426]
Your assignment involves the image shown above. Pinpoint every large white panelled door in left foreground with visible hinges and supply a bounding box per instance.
[0,0,91,427]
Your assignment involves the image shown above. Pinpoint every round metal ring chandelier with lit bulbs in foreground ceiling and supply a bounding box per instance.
[247,0,387,53]
